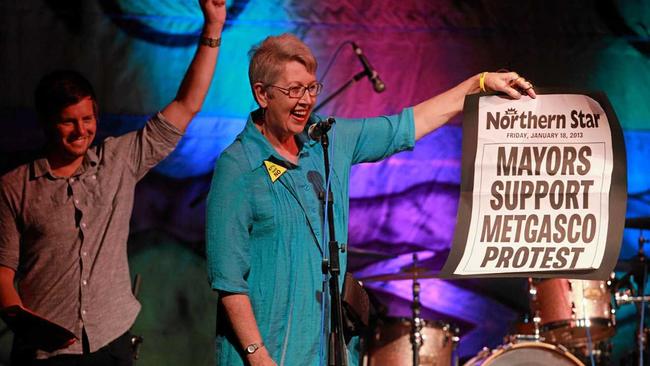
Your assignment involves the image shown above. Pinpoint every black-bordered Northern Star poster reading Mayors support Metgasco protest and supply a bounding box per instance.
[441,89,627,279]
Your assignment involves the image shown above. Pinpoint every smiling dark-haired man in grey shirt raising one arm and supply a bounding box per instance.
[0,0,226,365]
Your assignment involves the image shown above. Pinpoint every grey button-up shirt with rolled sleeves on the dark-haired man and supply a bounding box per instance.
[0,113,182,358]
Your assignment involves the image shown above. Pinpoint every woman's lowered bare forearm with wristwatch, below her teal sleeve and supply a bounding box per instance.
[219,292,276,365]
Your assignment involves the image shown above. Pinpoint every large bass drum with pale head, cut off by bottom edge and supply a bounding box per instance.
[465,342,584,366]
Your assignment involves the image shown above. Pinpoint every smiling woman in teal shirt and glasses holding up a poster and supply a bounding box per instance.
[206,34,535,365]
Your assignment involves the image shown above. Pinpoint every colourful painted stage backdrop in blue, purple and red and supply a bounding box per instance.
[0,0,650,365]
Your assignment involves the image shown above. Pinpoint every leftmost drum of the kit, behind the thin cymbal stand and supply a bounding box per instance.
[367,318,458,366]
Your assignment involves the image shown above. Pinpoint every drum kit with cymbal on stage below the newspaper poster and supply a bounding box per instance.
[354,218,650,366]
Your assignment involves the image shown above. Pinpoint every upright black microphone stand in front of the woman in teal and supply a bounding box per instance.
[319,129,348,366]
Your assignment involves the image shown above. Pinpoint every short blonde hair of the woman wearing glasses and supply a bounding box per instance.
[248,33,318,88]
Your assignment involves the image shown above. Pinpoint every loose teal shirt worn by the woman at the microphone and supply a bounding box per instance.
[206,108,415,365]
